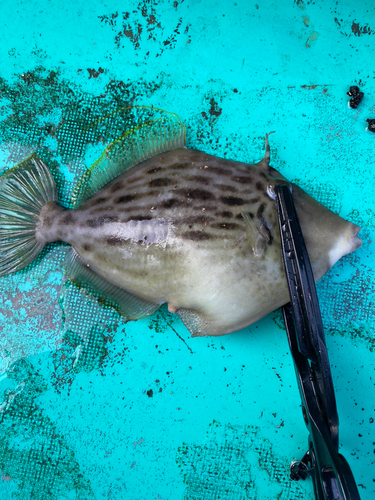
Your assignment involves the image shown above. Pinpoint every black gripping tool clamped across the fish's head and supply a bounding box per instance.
[275,184,360,500]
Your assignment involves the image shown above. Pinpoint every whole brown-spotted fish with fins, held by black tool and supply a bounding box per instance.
[0,109,362,336]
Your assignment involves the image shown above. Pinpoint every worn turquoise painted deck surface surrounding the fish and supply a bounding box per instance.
[0,0,375,500]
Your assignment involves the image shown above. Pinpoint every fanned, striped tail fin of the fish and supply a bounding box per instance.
[0,154,57,276]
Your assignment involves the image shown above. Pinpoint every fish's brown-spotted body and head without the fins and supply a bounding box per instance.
[36,148,360,335]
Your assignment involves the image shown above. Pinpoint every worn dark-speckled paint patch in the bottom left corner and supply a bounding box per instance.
[0,359,95,500]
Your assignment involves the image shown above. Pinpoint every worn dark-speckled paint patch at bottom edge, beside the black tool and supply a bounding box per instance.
[176,421,313,500]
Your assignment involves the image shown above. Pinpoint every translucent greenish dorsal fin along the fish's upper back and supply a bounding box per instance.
[71,110,186,208]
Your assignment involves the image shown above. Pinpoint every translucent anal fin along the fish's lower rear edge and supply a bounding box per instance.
[65,248,160,320]
